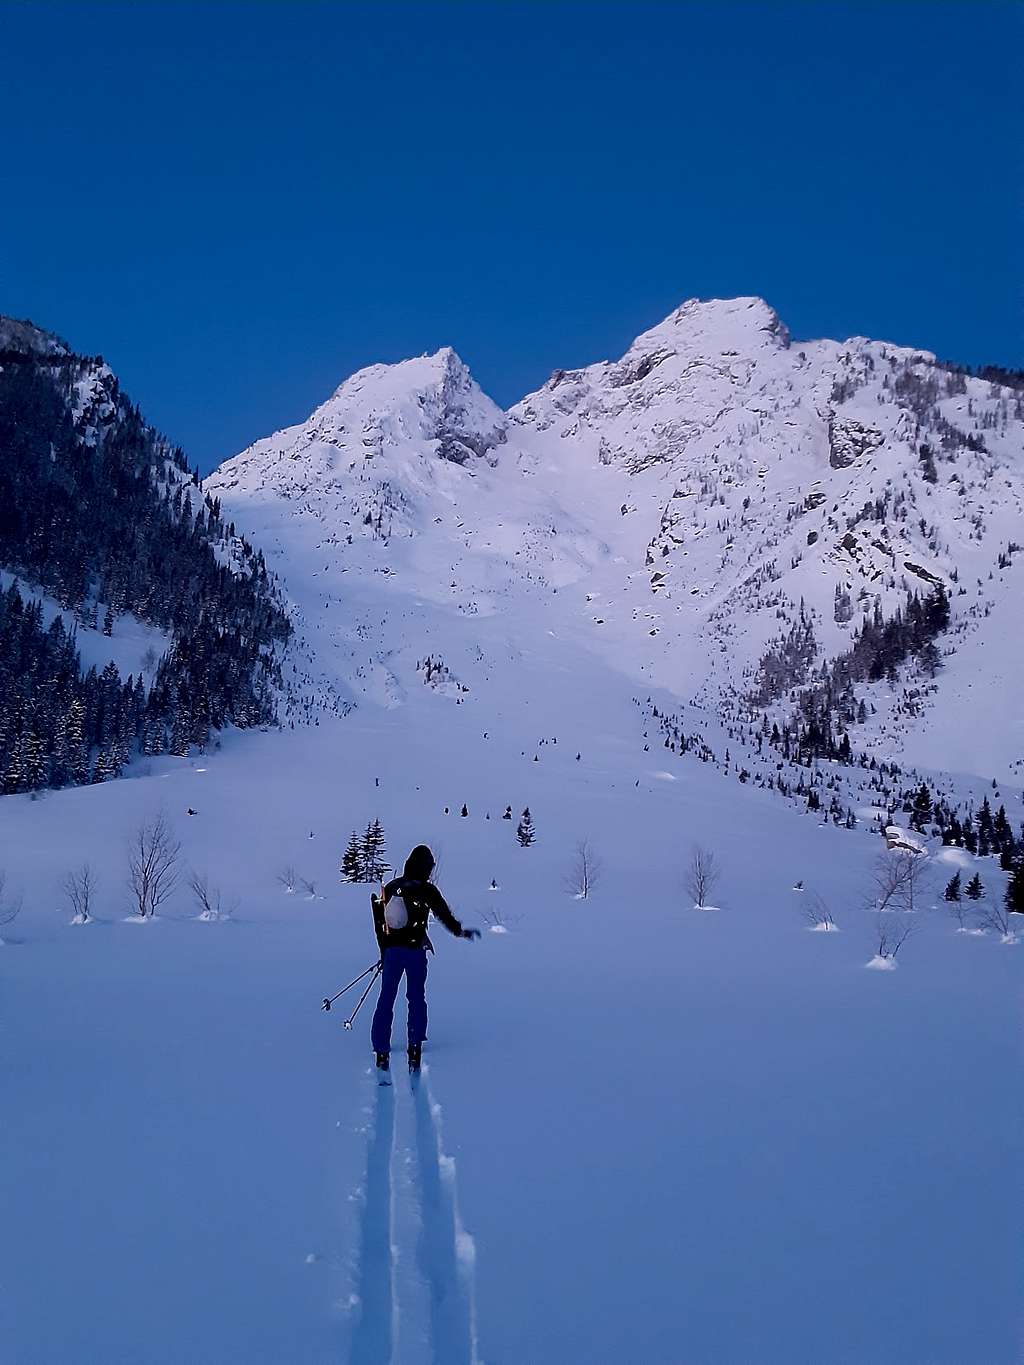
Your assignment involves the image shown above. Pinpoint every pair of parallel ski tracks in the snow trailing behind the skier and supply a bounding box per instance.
[350,1066,482,1365]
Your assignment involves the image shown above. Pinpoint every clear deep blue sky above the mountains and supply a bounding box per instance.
[0,0,1024,470]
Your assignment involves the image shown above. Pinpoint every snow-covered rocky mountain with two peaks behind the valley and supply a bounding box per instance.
[208,299,1024,797]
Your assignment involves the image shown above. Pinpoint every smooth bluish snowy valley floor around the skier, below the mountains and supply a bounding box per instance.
[0,696,1024,1365]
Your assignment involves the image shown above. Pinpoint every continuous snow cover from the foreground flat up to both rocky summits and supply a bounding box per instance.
[0,302,1024,1365]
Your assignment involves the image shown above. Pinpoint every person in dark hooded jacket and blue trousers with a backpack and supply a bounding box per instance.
[370,844,481,1072]
